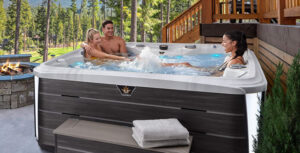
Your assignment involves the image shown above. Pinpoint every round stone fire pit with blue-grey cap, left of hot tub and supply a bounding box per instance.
[0,55,39,109]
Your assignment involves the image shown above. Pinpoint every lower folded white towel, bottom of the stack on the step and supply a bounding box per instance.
[132,129,190,148]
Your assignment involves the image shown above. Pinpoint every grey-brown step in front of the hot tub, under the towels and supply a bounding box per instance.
[53,119,192,153]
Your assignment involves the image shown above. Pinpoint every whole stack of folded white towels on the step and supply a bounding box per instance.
[132,119,190,148]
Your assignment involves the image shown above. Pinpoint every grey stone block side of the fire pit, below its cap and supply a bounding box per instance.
[0,78,34,109]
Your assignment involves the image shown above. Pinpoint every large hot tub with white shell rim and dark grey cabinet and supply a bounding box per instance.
[34,43,267,153]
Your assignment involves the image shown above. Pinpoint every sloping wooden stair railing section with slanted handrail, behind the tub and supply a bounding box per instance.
[162,0,202,43]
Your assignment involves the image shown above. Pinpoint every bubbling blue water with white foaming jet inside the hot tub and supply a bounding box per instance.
[70,47,226,76]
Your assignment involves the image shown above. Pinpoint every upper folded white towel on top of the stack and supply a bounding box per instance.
[133,118,189,141]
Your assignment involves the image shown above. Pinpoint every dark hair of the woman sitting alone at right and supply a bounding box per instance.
[224,31,248,59]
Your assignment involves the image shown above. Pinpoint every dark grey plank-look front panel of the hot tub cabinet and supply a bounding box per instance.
[38,78,248,153]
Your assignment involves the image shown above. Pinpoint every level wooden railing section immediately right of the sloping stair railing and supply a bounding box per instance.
[213,0,260,20]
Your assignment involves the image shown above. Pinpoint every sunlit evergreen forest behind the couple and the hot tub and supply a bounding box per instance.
[0,0,196,60]
